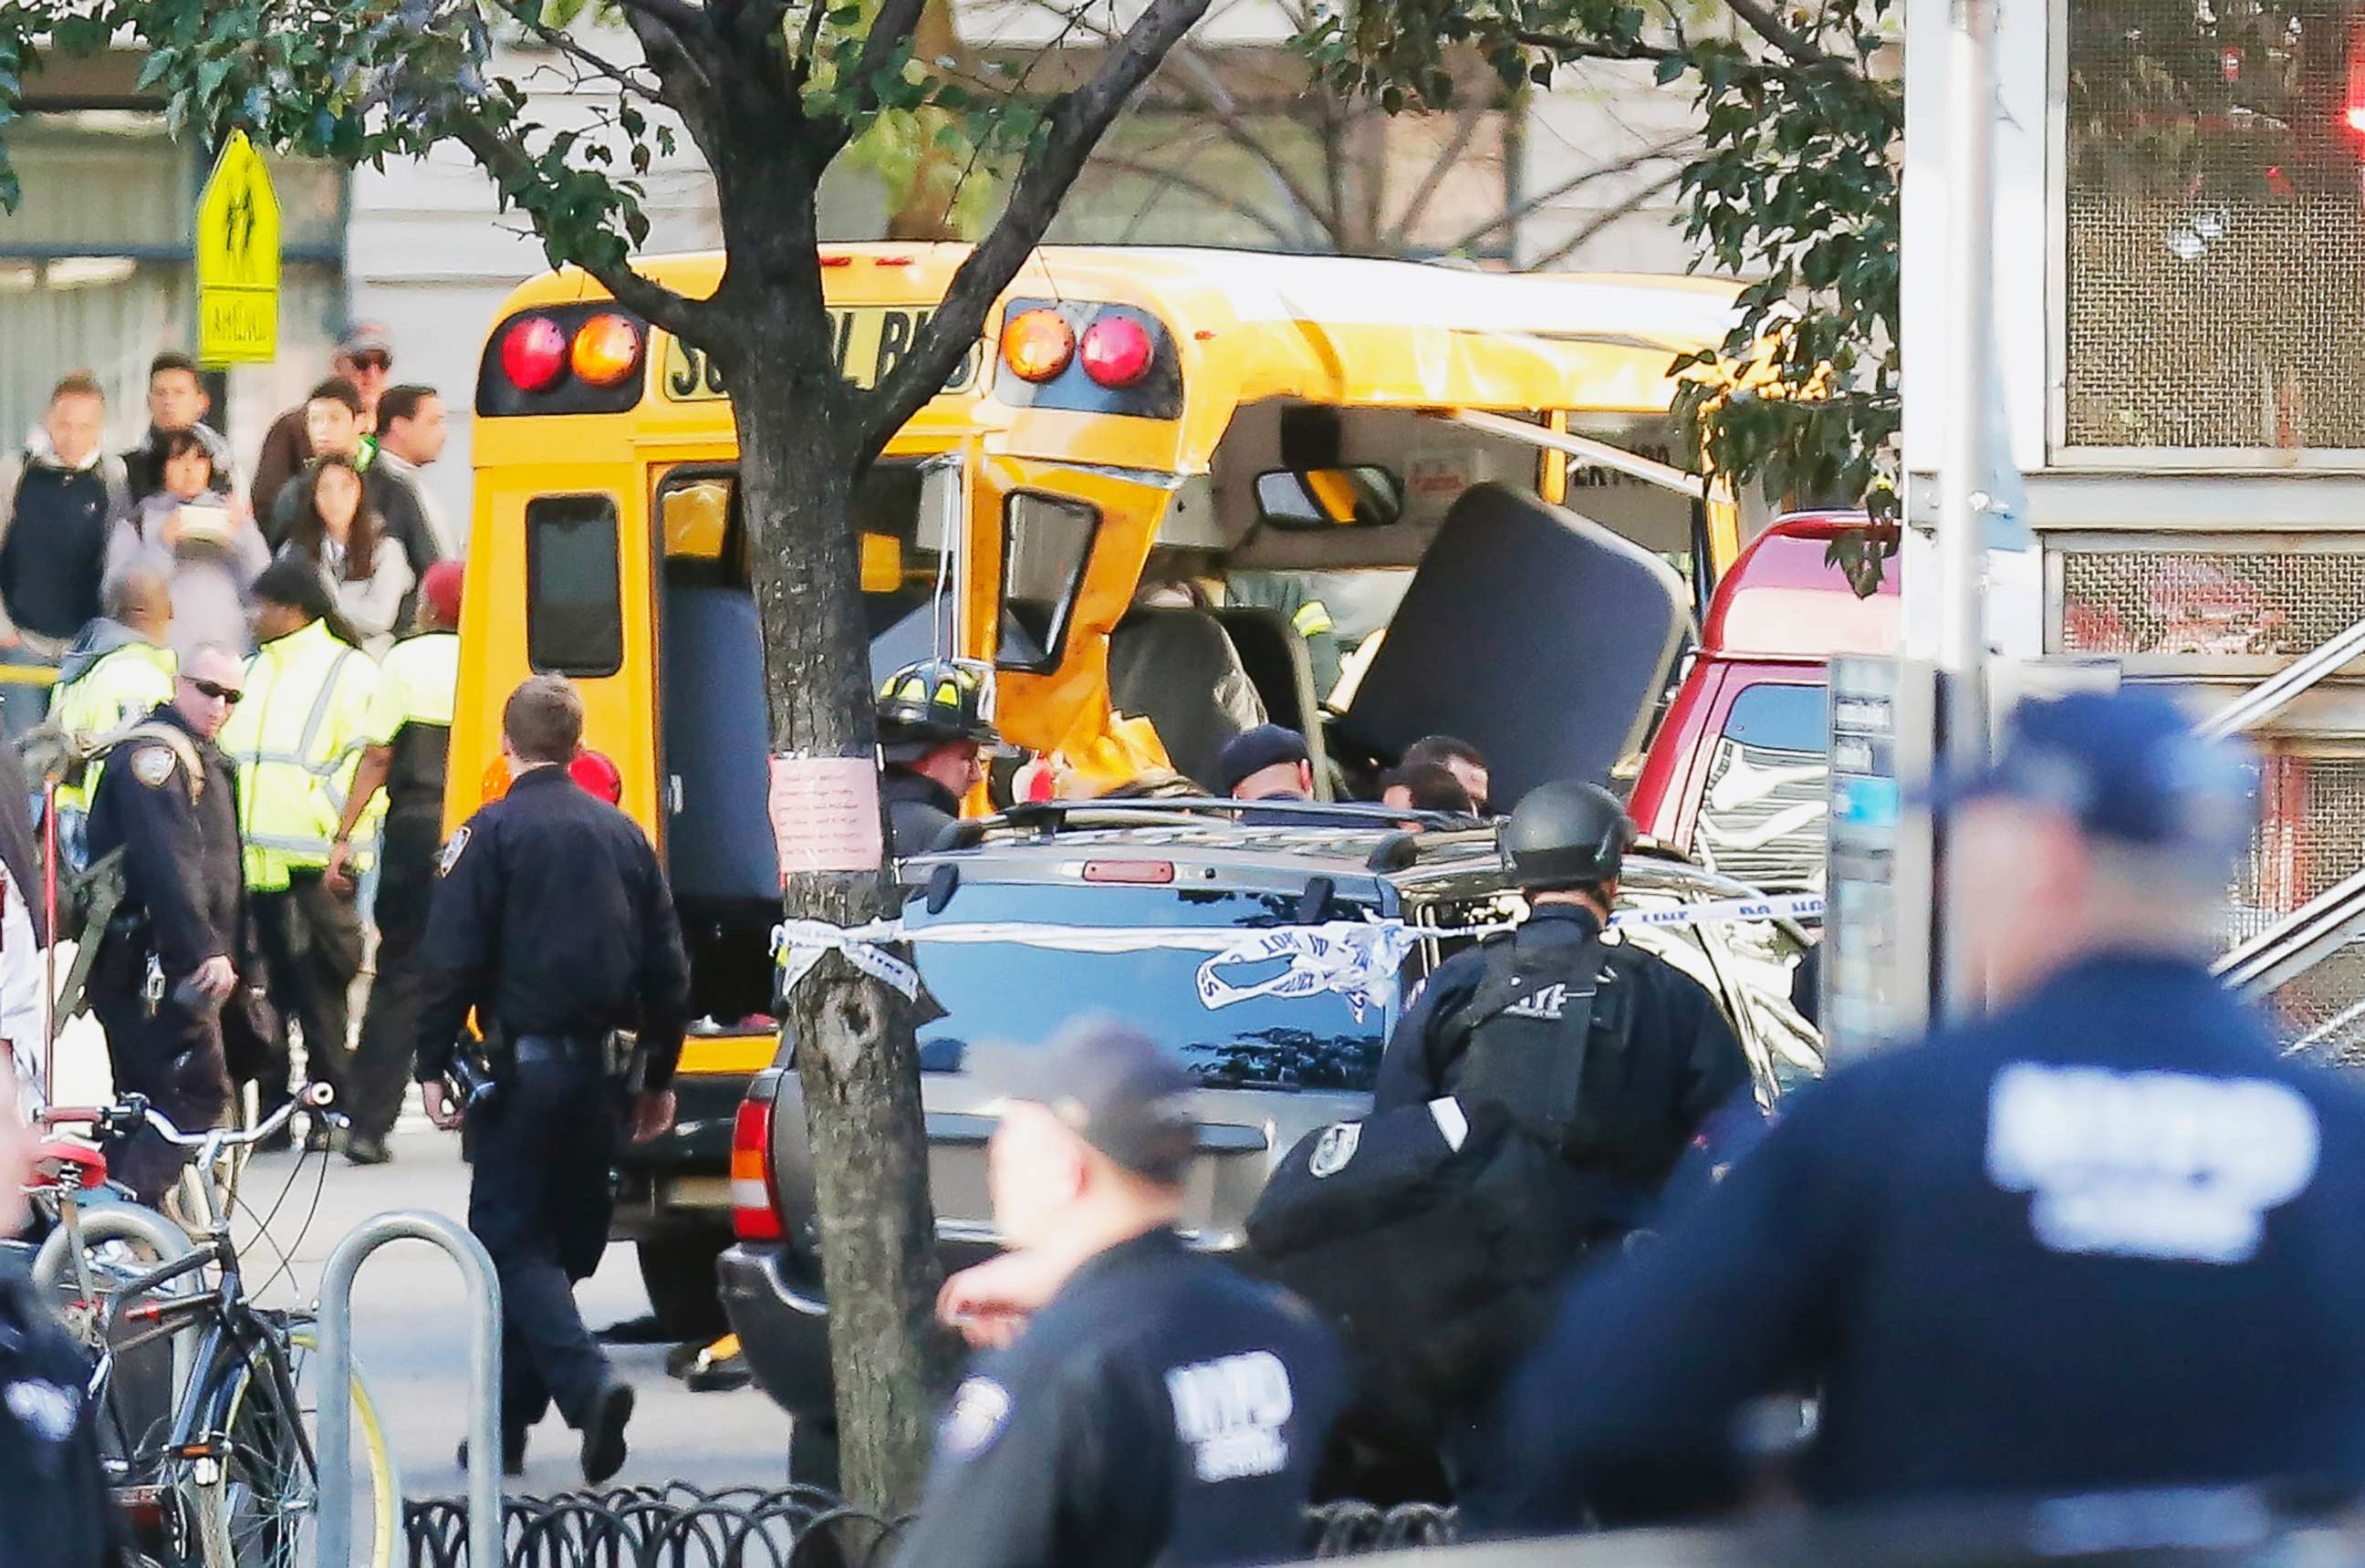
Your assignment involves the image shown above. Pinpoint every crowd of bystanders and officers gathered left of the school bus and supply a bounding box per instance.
[0,327,466,1178]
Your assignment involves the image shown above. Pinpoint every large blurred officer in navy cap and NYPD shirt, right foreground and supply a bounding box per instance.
[1490,693,2365,1528]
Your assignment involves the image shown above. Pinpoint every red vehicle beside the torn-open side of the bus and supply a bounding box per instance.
[1627,511,1899,887]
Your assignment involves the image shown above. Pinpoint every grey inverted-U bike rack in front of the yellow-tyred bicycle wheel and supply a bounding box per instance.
[319,1209,504,1568]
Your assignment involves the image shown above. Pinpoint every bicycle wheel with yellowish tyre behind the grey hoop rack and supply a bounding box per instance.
[177,1329,402,1568]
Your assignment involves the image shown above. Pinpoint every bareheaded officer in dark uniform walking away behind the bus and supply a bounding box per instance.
[416,677,691,1483]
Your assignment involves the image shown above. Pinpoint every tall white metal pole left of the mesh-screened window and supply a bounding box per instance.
[1933,0,1996,1019]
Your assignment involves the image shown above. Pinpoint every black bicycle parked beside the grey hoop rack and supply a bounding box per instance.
[33,1095,402,1568]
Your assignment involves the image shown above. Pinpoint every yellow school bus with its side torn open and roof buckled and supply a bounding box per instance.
[447,244,1745,1295]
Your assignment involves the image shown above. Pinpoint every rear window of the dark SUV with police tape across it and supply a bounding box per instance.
[906,882,1395,1093]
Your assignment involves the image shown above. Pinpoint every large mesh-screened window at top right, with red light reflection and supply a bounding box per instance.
[2062,0,2365,450]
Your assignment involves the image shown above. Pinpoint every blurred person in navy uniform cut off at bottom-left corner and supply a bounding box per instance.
[0,1093,132,1568]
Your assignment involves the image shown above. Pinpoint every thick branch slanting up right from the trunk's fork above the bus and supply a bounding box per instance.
[860,0,1209,456]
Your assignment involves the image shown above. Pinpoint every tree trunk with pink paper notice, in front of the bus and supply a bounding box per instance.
[731,319,951,1519]
